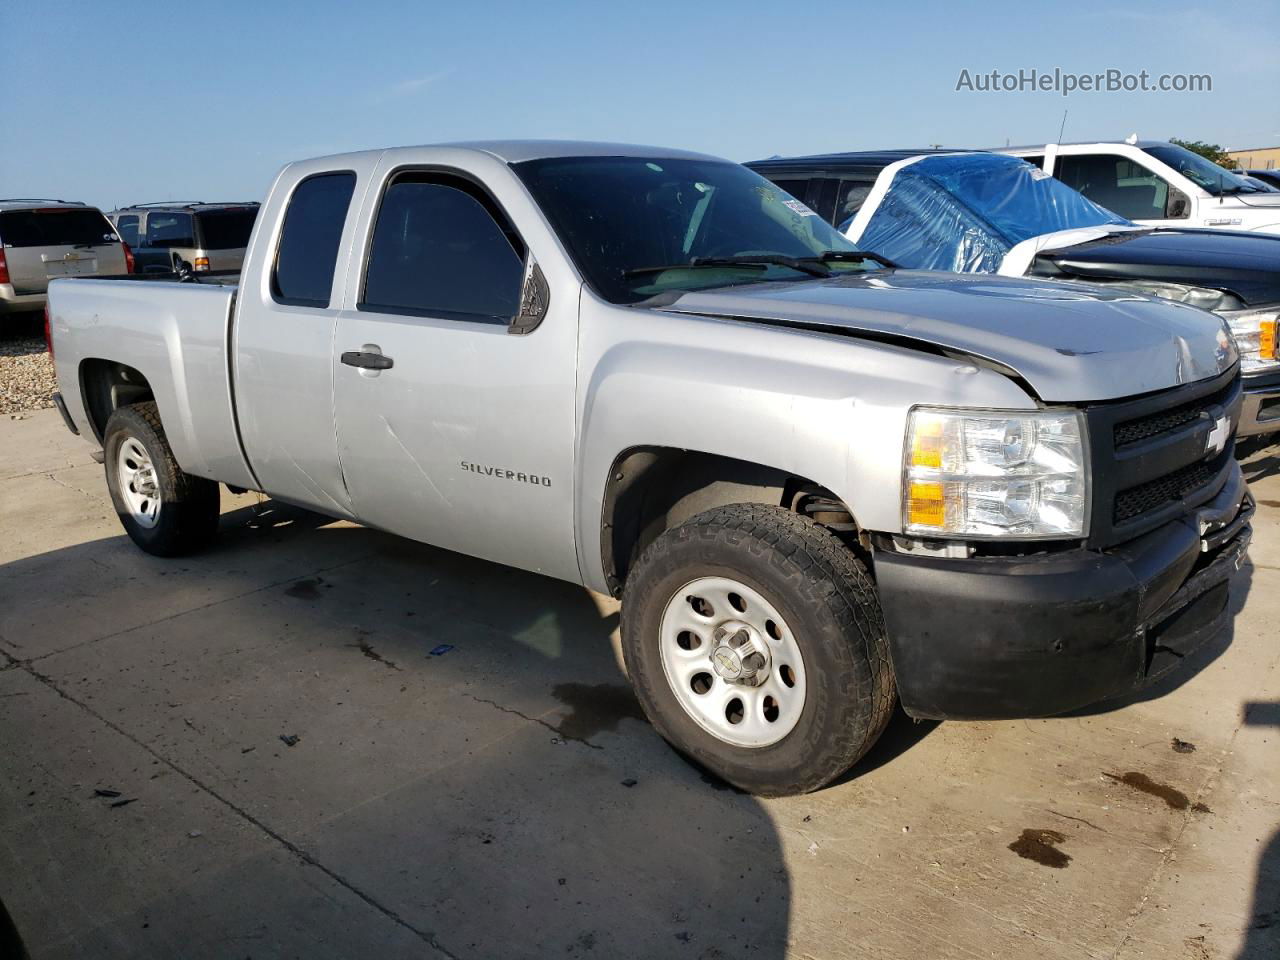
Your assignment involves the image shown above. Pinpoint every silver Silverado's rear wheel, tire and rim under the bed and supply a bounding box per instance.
[102,402,220,557]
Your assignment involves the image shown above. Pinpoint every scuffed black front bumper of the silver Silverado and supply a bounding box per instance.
[876,467,1254,719]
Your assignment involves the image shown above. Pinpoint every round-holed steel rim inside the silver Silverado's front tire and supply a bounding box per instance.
[659,577,805,746]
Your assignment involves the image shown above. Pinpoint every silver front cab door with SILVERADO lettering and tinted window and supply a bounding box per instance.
[333,166,579,580]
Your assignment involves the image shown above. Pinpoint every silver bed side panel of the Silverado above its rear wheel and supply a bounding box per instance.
[49,279,255,488]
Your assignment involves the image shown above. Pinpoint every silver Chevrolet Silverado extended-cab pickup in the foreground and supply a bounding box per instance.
[50,142,1253,795]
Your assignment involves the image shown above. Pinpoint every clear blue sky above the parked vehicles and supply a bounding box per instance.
[0,0,1280,207]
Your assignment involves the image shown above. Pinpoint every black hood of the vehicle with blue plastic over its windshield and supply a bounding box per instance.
[1032,229,1280,306]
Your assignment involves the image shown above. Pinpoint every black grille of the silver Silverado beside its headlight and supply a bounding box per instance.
[1085,370,1242,548]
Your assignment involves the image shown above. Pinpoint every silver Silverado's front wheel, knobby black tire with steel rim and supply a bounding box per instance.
[622,503,895,796]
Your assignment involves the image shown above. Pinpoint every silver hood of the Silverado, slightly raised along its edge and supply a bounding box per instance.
[658,270,1236,403]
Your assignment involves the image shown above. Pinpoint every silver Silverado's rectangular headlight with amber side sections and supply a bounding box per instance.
[902,407,1089,539]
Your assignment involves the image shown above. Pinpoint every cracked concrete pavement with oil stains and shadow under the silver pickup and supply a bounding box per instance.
[0,411,1280,960]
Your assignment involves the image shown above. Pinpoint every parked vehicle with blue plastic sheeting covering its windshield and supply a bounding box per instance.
[750,151,1280,436]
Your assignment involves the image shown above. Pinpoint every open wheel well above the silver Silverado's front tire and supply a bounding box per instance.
[600,447,860,596]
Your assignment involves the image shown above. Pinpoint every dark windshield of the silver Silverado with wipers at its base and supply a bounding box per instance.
[512,156,881,303]
